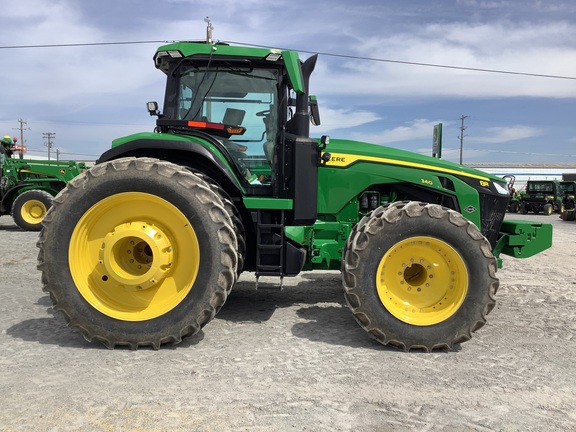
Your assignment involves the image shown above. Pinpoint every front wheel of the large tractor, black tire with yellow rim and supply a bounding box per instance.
[342,202,498,351]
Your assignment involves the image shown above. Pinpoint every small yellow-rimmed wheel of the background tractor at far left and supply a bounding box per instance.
[12,189,52,231]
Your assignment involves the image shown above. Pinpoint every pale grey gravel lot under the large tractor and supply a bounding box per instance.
[0,211,576,431]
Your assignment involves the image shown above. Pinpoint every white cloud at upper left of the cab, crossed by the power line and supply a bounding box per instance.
[0,0,163,114]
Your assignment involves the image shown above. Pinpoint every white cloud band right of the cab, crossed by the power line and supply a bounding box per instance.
[315,22,576,99]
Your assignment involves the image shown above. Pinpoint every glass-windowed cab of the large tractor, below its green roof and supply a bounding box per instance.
[153,56,286,186]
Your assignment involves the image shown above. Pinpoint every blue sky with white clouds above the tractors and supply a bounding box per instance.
[0,0,576,164]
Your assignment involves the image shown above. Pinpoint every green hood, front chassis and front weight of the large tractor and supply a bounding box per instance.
[296,140,552,269]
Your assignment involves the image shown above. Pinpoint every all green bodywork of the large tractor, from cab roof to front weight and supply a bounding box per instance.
[104,42,552,269]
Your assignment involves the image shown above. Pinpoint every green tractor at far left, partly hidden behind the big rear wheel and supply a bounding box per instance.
[0,136,86,231]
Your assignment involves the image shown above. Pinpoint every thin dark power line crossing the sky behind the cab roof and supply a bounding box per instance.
[0,40,576,80]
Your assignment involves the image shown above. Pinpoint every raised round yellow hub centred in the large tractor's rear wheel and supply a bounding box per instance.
[99,221,173,291]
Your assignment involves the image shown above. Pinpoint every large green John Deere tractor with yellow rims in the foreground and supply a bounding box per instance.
[38,27,552,351]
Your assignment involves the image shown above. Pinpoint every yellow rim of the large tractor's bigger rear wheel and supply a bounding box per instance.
[68,192,200,321]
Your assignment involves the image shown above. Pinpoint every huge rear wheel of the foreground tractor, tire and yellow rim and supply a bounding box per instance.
[38,158,238,349]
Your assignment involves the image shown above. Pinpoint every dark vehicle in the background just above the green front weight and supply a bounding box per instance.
[520,180,564,215]
